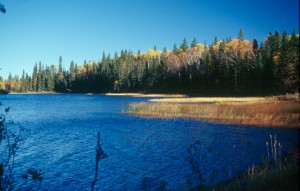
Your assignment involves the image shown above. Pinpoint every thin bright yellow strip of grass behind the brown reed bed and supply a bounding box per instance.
[149,97,268,103]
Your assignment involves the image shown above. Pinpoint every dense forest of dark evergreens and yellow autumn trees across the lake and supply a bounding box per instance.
[0,29,299,96]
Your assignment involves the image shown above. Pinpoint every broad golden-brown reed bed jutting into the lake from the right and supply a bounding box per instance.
[127,99,300,127]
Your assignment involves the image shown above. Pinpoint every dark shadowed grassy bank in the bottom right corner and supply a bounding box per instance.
[215,135,299,191]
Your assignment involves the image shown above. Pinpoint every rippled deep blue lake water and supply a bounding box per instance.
[0,94,299,190]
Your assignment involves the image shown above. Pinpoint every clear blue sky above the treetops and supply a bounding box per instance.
[0,0,299,78]
